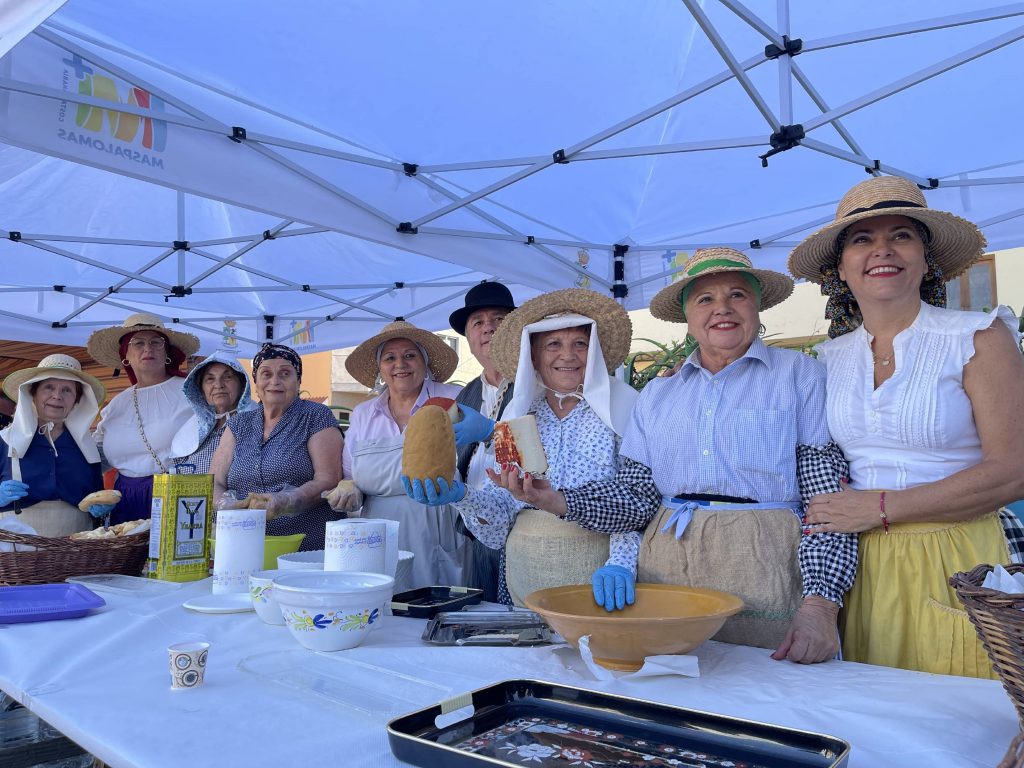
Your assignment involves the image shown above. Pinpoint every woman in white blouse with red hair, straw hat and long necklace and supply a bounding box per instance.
[88,312,199,524]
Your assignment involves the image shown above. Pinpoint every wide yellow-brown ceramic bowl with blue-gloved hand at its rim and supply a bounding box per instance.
[525,584,743,670]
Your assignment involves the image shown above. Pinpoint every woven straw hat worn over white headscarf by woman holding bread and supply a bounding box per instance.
[490,288,633,380]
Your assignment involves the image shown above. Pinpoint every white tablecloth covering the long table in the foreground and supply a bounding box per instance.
[0,581,1018,768]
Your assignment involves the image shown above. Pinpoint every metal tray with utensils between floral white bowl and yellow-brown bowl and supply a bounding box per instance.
[422,610,555,645]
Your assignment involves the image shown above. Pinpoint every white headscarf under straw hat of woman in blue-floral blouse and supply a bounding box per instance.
[502,313,639,437]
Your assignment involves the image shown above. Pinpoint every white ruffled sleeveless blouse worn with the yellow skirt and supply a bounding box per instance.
[817,302,1018,490]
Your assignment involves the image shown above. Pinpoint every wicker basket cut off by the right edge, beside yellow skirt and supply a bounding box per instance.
[949,565,1024,727]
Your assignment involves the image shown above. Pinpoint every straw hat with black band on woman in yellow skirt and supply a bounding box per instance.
[790,176,987,283]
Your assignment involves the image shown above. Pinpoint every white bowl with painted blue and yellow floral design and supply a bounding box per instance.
[273,571,394,651]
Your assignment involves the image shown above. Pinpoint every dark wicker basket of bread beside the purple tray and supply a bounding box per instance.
[0,530,150,586]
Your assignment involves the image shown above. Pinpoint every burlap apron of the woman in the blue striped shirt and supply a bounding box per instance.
[637,504,803,648]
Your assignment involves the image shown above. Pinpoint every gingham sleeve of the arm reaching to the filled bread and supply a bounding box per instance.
[561,456,662,534]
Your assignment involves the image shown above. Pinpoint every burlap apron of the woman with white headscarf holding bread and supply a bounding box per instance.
[505,509,608,606]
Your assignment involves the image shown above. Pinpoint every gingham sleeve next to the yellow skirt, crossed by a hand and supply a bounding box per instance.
[797,442,858,606]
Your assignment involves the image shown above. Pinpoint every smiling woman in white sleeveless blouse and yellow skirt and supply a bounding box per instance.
[790,177,1024,677]
